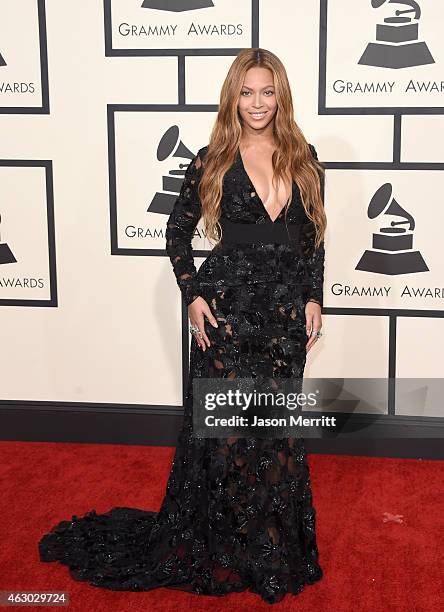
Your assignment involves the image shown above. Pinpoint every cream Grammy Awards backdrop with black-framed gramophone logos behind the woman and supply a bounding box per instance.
[0,0,444,425]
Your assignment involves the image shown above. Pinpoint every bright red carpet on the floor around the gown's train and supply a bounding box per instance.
[0,442,444,612]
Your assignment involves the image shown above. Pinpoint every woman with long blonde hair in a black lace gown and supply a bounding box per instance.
[39,49,326,603]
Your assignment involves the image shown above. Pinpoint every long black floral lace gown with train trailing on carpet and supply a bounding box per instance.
[39,145,324,604]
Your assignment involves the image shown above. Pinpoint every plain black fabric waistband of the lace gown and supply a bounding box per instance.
[219,217,301,243]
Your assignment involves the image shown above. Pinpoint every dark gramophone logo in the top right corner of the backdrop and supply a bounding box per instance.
[358,0,435,68]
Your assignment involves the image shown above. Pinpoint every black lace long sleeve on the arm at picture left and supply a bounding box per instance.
[165,153,202,306]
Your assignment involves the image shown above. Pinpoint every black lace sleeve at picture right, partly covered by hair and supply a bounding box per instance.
[302,144,325,308]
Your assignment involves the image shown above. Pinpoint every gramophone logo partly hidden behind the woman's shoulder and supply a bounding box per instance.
[147,125,194,215]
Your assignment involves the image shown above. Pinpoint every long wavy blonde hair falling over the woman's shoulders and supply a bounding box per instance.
[198,48,327,248]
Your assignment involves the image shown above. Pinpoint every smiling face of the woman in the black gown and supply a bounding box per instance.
[238,67,277,130]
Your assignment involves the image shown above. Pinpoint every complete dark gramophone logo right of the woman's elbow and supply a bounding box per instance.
[355,183,429,275]
